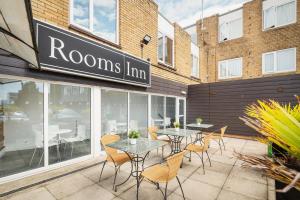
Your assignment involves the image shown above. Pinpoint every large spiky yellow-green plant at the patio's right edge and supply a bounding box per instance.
[236,96,300,199]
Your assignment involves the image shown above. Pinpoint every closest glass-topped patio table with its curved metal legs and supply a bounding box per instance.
[107,138,167,199]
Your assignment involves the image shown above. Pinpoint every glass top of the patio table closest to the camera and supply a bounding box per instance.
[107,138,167,155]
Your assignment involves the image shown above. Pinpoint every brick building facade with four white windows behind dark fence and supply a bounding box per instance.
[186,0,300,82]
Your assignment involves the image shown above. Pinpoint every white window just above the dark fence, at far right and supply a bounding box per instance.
[262,48,296,74]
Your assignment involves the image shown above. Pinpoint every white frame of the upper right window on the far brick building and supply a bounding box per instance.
[262,0,297,31]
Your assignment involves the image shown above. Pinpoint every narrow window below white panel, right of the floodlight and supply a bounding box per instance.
[158,33,173,66]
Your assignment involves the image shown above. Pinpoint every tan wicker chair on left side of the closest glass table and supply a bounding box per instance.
[99,135,132,191]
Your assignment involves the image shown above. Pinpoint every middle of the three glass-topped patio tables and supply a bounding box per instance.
[157,128,198,155]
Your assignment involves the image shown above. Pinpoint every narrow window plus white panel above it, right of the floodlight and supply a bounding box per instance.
[158,14,174,66]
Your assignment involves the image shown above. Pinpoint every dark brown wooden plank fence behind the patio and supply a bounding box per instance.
[187,74,300,136]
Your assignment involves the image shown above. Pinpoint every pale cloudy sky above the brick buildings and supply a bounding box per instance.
[155,0,249,27]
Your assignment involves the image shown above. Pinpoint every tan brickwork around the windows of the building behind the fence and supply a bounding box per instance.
[197,0,300,82]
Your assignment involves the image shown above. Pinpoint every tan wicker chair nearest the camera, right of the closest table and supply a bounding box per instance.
[141,151,185,200]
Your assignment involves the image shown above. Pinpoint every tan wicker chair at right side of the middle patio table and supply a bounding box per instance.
[185,133,212,174]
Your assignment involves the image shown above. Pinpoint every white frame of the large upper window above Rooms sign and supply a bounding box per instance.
[69,0,120,45]
